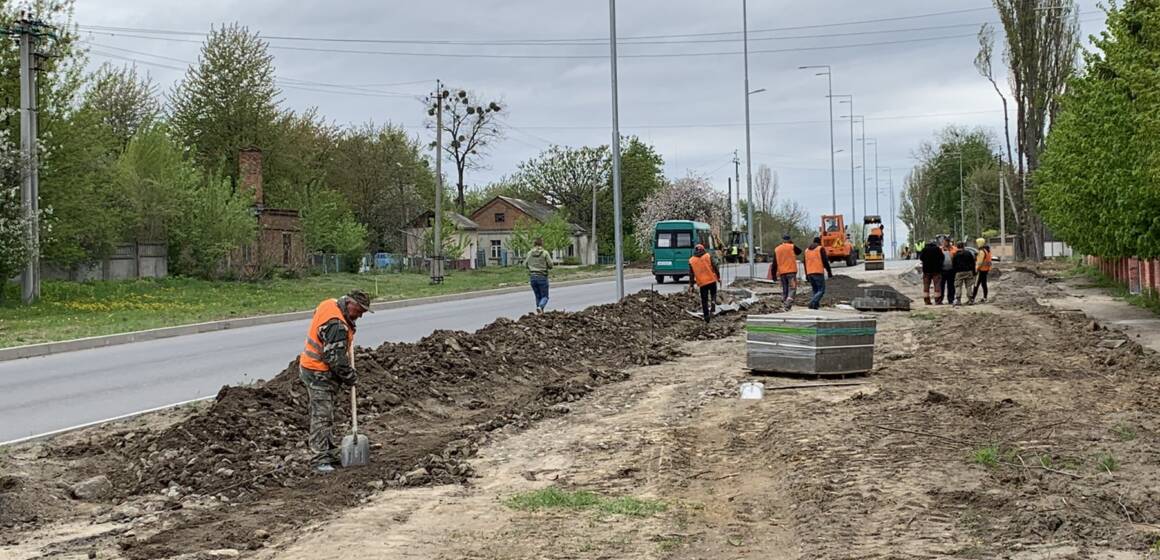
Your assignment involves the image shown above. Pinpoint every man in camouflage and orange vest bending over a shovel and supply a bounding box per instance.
[298,290,370,473]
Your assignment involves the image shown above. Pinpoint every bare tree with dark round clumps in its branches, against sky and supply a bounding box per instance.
[427,88,506,214]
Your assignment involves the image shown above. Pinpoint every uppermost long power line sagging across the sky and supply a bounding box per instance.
[78,6,993,46]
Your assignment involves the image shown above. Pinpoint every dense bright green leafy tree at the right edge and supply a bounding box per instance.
[1035,1,1160,259]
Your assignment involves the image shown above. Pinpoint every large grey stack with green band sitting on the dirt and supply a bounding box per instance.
[746,310,877,376]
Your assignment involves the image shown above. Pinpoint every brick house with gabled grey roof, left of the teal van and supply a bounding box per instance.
[471,196,593,266]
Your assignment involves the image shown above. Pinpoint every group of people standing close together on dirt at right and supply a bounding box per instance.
[919,237,994,307]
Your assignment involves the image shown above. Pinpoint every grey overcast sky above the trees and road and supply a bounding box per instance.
[77,0,1103,245]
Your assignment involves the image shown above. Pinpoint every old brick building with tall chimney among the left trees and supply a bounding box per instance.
[227,147,307,276]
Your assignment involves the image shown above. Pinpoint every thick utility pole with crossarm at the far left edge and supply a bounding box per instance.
[13,19,48,304]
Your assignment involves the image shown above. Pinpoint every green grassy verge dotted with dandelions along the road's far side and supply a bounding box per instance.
[0,267,611,348]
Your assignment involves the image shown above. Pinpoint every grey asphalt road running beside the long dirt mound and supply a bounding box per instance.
[0,261,914,443]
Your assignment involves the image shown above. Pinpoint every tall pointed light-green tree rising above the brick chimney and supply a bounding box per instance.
[169,23,281,184]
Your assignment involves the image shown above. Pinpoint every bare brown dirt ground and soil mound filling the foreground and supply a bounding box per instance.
[0,265,1160,560]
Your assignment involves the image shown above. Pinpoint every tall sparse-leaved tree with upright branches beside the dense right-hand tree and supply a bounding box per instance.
[980,0,1080,261]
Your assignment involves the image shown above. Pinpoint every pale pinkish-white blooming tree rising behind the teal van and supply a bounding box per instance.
[635,175,728,254]
